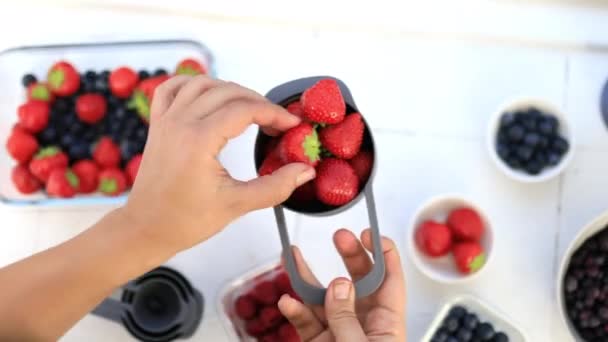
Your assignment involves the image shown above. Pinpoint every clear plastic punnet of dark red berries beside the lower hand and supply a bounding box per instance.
[217,261,300,342]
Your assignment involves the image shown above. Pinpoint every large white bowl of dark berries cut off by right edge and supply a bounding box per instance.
[557,212,608,341]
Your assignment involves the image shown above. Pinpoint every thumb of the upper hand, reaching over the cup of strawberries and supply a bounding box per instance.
[239,163,315,211]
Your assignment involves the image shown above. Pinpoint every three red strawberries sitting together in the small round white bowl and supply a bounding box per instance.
[414,208,486,274]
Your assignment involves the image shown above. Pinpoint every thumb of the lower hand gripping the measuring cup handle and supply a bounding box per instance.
[325,278,367,342]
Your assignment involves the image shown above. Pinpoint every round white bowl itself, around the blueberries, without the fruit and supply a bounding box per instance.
[486,98,576,183]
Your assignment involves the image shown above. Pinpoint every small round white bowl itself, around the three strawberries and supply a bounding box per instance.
[406,195,494,284]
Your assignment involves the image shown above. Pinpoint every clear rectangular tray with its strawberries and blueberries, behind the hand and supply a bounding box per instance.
[0,40,215,207]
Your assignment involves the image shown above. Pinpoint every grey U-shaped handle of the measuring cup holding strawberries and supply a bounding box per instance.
[274,183,386,305]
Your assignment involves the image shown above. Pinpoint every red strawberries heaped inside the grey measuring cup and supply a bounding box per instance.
[258,79,373,208]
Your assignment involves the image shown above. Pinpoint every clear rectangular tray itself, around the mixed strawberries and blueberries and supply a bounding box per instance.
[0,40,215,207]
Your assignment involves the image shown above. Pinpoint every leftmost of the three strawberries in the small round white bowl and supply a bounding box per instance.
[415,221,452,258]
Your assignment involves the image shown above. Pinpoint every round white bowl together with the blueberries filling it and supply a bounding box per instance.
[487,98,575,183]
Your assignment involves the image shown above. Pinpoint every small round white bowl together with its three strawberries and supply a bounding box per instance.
[407,195,494,284]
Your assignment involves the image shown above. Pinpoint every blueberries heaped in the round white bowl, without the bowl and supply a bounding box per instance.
[496,107,570,175]
